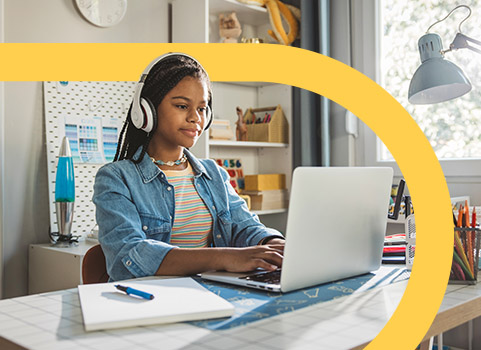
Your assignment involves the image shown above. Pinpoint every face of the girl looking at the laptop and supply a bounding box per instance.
[155,76,209,150]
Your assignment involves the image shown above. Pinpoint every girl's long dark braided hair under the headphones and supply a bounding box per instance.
[114,54,212,164]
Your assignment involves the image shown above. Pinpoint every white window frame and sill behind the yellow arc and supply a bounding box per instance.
[352,0,481,177]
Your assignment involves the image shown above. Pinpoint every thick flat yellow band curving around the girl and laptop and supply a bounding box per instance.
[0,43,453,350]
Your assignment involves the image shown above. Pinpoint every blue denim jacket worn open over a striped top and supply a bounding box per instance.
[93,149,282,280]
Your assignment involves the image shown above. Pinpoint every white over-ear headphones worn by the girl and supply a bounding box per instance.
[130,52,213,133]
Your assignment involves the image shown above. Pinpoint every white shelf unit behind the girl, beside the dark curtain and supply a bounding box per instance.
[172,0,292,232]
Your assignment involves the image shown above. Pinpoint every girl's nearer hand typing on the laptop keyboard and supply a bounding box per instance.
[221,242,284,272]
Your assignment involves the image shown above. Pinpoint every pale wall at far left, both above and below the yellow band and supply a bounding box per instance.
[0,0,170,297]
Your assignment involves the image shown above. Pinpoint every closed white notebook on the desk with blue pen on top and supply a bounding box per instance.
[78,277,234,331]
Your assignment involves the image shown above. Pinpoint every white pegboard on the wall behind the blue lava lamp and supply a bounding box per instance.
[43,81,137,238]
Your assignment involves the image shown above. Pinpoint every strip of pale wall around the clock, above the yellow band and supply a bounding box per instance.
[4,0,169,43]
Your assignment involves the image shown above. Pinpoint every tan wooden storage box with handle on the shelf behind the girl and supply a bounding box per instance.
[244,105,289,143]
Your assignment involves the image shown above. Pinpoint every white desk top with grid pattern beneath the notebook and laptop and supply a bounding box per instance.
[0,270,481,350]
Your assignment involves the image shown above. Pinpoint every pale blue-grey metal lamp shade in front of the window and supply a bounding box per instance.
[408,33,471,104]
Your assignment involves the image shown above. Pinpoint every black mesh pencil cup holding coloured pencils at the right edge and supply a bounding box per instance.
[449,227,481,284]
